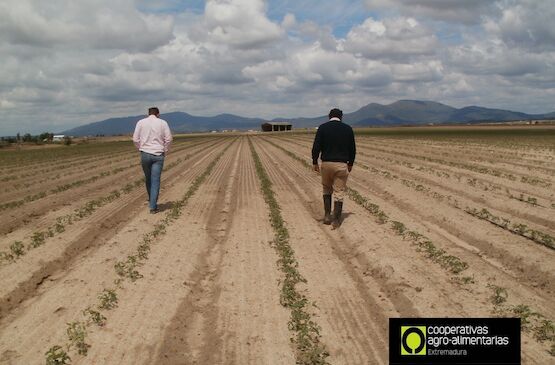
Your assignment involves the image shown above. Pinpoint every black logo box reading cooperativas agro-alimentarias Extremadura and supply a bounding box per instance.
[389,318,521,365]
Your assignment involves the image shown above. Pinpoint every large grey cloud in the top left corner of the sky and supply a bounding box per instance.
[0,0,173,52]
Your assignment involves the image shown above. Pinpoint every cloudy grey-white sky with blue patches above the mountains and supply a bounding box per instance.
[0,0,555,135]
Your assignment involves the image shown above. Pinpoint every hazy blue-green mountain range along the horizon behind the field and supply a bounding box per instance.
[62,100,555,136]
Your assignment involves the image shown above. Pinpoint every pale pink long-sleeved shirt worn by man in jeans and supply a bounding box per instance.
[133,115,173,156]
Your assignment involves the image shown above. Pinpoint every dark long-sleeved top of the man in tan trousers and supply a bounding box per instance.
[312,120,356,166]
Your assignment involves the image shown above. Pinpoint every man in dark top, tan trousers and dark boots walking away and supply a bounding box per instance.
[312,109,356,229]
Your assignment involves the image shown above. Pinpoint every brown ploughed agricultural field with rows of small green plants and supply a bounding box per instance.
[0,126,555,365]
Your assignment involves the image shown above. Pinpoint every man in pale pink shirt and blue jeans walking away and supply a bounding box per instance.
[133,108,173,214]
